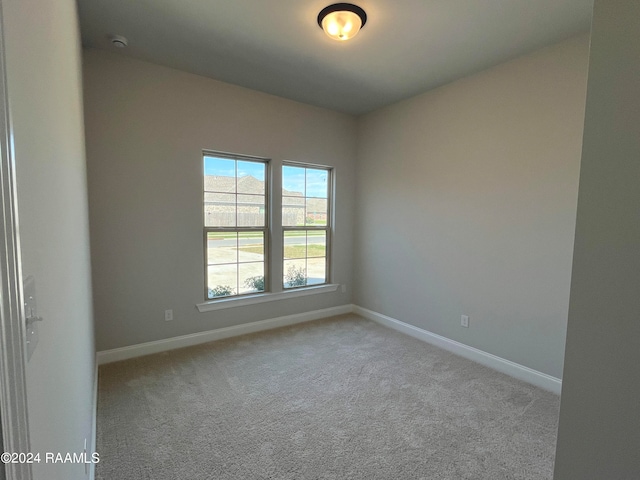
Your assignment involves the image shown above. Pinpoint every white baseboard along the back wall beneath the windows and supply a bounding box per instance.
[97,305,353,365]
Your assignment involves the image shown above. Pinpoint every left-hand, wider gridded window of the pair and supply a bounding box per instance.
[204,153,269,300]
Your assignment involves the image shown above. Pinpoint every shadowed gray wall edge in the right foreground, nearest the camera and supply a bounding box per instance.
[554,0,640,480]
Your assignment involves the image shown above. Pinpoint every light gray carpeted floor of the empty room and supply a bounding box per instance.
[96,315,560,480]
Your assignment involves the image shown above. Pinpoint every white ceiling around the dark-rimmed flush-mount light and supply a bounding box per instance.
[78,0,593,114]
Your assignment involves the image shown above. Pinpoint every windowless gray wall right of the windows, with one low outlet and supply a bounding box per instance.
[354,34,588,377]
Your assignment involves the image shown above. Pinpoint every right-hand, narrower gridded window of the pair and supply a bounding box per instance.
[282,163,331,289]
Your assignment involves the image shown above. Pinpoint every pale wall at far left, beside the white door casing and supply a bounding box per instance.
[2,0,95,480]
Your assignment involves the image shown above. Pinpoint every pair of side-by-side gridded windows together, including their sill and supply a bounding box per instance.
[204,152,337,302]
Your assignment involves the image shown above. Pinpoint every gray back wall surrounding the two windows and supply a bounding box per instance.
[84,50,356,350]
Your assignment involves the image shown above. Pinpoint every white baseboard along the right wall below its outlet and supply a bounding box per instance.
[353,305,562,395]
